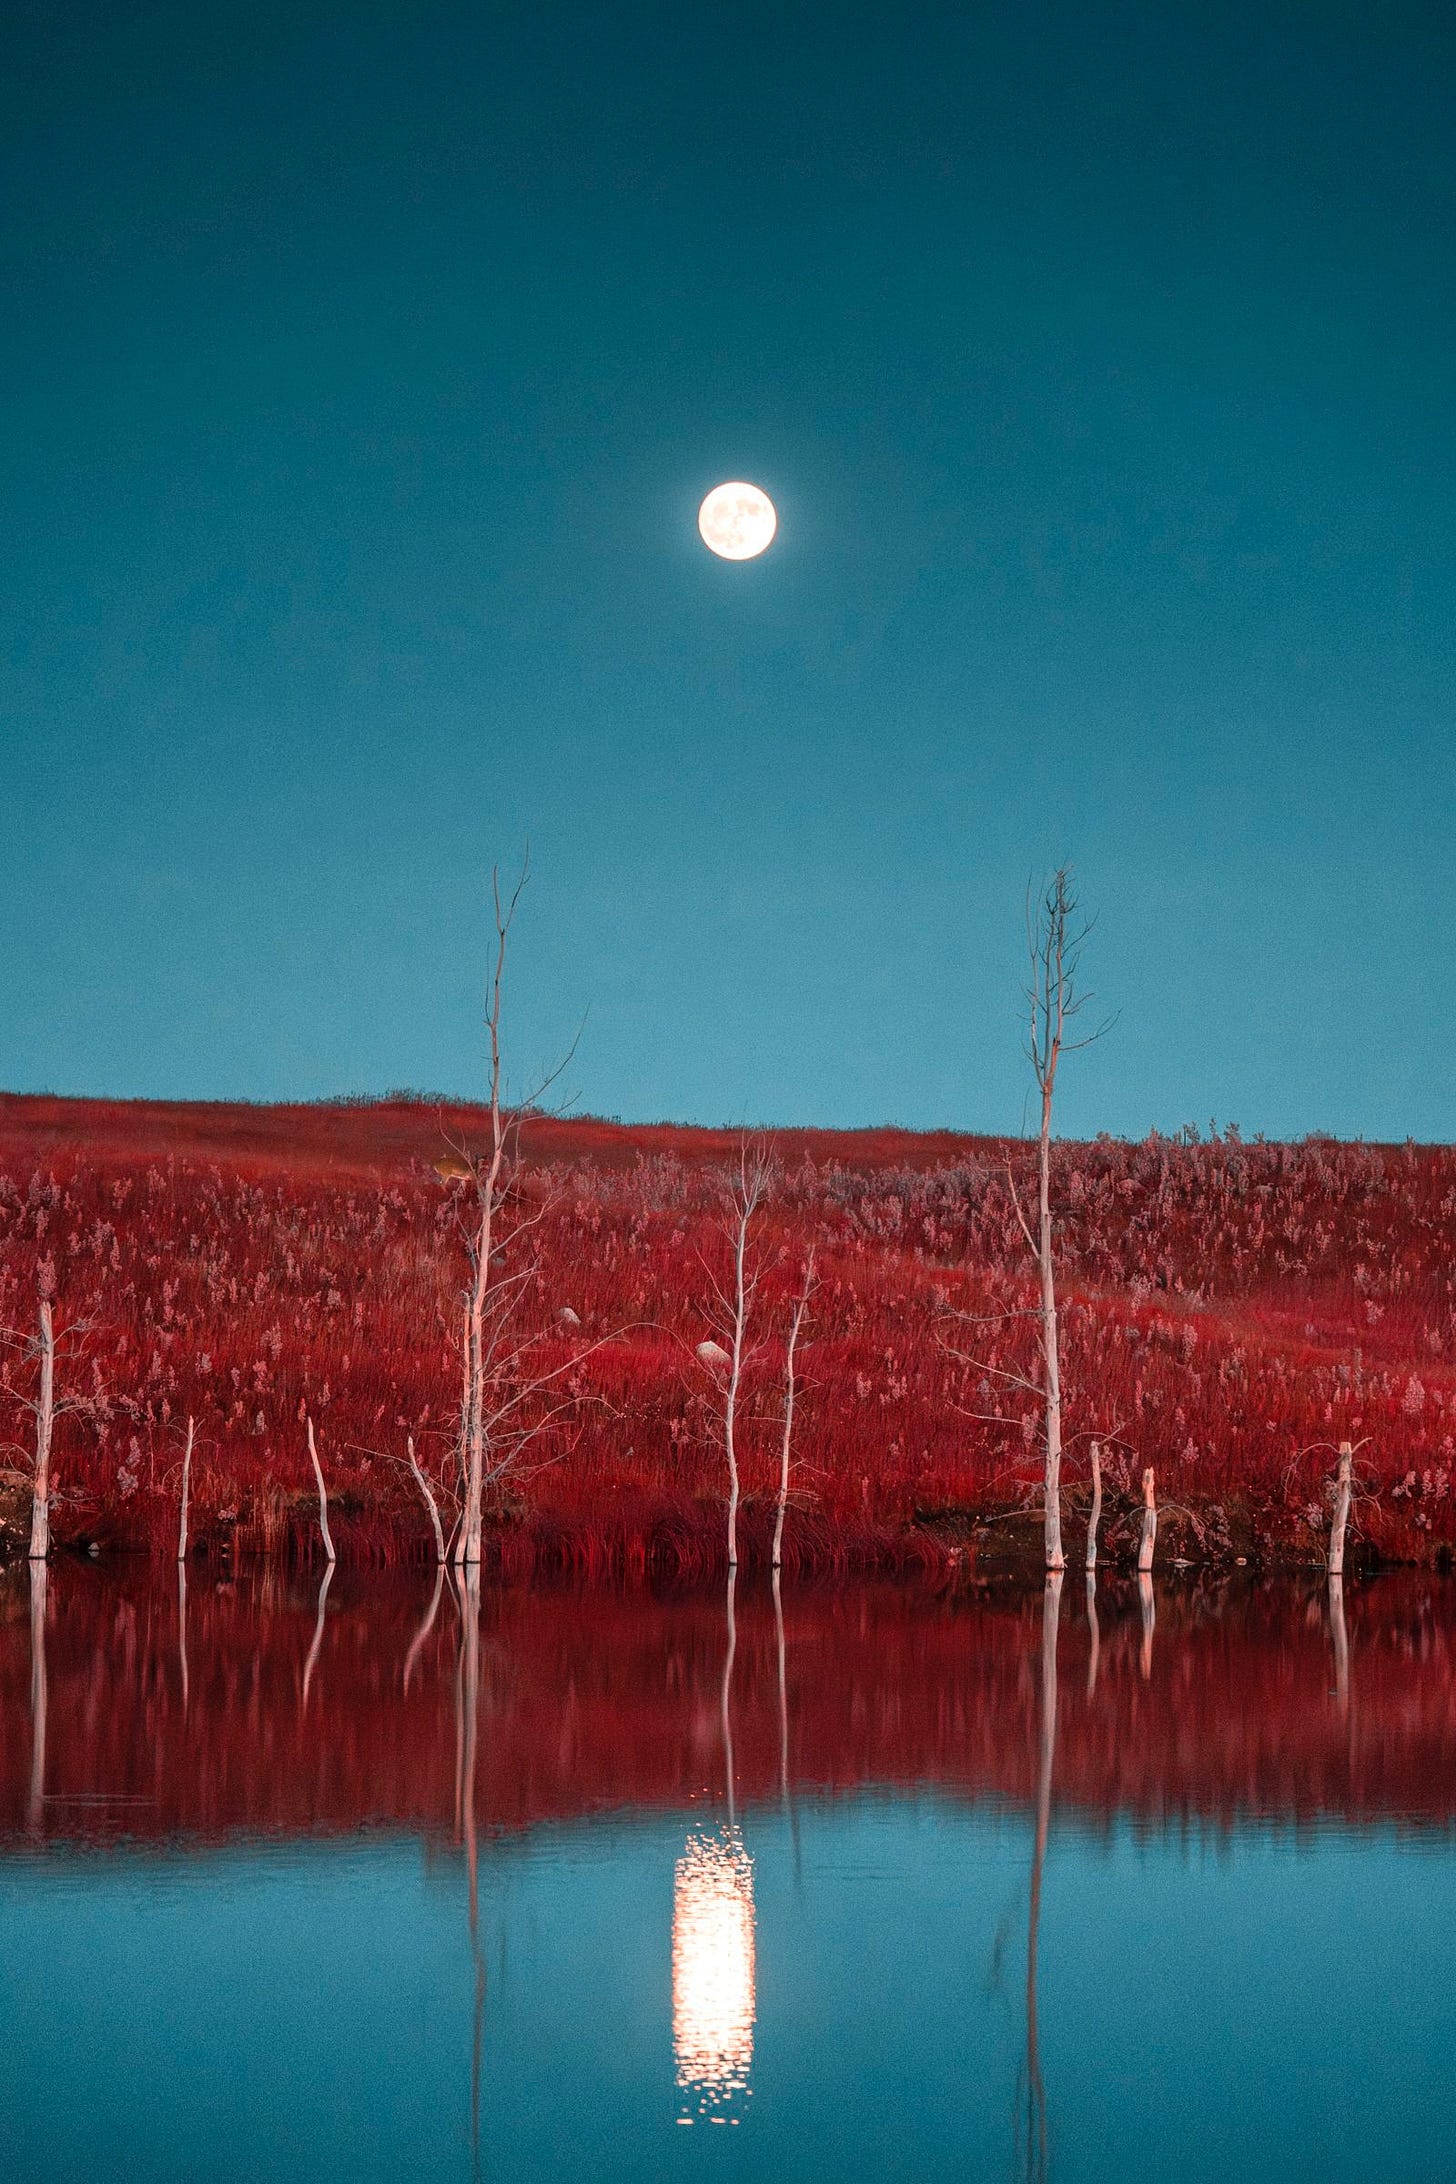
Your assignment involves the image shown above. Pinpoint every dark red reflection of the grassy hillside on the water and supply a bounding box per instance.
[0,1564,1456,1841]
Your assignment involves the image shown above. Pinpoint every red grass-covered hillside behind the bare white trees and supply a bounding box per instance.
[0,1099,1456,1568]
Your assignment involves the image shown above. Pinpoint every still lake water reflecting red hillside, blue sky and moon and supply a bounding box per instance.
[0,1564,1456,2184]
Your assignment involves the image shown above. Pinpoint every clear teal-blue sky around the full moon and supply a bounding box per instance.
[0,0,1456,1138]
